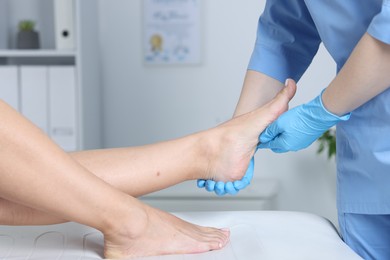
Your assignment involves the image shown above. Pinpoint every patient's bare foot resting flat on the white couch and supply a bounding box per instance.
[104,199,229,259]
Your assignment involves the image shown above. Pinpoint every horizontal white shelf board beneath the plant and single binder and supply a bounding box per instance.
[0,50,76,58]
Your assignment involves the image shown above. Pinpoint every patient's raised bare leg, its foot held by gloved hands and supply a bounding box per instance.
[0,81,296,221]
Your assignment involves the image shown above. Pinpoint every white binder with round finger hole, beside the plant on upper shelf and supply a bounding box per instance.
[54,0,76,50]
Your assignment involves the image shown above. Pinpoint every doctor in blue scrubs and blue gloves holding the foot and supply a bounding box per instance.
[198,0,390,259]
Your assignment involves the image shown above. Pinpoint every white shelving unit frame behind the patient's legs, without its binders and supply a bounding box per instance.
[0,0,101,150]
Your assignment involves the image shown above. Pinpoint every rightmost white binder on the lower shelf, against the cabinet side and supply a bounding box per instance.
[48,66,78,151]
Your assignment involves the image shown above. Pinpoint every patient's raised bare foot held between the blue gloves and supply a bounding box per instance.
[204,80,296,182]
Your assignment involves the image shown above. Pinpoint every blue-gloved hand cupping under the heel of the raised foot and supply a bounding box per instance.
[197,157,255,196]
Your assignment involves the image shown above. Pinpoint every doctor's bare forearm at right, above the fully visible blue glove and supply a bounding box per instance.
[322,33,390,116]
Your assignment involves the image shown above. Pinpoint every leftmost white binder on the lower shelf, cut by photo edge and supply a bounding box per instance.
[0,66,19,111]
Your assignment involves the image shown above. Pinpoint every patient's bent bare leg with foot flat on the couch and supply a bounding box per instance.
[0,101,229,258]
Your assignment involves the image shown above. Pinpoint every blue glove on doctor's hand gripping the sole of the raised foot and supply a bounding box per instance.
[258,92,350,153]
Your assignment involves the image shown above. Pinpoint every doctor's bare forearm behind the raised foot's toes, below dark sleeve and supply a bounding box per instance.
[234,70,284,117]
